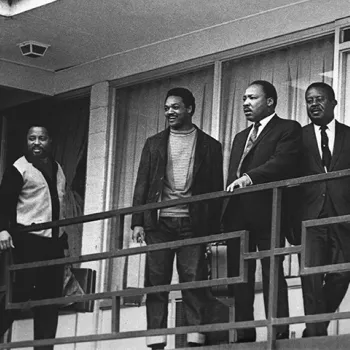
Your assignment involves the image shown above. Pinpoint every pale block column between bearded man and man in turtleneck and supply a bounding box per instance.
[76,82,111,350]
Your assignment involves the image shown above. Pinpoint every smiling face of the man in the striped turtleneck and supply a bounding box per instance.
[164,96,192,130]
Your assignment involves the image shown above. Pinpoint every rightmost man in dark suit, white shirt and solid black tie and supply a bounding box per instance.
[301,82,350,337]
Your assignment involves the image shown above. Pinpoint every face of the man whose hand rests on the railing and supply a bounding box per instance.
[243,85,273,122]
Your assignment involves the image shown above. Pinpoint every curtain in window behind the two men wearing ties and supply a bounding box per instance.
[219,36,334,279]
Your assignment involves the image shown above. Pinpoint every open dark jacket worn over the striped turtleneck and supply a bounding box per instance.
[131,127,223,236]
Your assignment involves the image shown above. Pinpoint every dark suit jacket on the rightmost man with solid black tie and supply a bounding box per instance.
[301,122,350,252]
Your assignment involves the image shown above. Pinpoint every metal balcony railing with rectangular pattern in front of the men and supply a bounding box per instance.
[0,169,350,349]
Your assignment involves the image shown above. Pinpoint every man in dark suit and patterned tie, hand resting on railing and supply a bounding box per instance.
[223,80,301,342]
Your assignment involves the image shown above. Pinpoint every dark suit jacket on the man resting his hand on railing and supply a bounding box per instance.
[224,115,301,235]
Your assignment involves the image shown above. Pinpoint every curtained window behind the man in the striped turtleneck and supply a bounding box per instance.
[111,67,213,288]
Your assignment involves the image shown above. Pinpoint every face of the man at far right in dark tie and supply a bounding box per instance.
[305,87,337,125]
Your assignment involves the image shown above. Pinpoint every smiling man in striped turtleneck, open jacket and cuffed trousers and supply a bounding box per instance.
[132,88,223,349]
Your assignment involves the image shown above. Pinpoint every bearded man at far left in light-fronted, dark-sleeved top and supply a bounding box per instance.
[0,124,66,350]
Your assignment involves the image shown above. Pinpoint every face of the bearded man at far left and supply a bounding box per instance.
[27,126,51,158]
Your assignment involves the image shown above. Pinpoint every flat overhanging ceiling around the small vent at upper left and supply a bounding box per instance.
[0,0,306,71]
